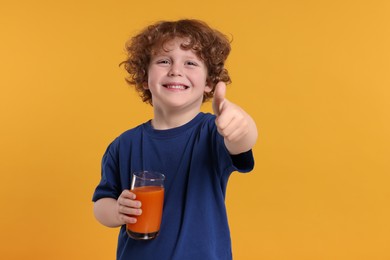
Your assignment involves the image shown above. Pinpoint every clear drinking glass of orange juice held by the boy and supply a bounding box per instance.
[126,171,165,240]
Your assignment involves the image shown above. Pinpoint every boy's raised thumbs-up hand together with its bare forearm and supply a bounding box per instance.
[212,82,257,154]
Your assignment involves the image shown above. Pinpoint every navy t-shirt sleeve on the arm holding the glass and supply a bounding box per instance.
[92,140,121,202]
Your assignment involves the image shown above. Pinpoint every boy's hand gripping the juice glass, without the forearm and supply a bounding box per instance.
[117,190,142,224]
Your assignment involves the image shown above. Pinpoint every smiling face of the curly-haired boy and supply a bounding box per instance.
[145,38,211,112]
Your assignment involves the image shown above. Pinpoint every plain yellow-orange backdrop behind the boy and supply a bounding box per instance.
[0,0,390,260]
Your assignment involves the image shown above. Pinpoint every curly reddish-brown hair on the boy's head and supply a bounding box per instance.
[120,19,231,104]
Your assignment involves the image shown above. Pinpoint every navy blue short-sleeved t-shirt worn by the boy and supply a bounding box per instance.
[93,113,254,260]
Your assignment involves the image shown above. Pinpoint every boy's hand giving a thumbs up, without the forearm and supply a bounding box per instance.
[212,82,251,144]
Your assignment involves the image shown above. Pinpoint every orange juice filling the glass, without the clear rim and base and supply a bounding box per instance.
[127,186,164,233]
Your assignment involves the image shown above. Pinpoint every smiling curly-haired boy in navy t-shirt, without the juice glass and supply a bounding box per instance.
[93,20,257,260]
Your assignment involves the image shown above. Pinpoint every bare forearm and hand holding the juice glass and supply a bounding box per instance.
[93,190,142,227]
